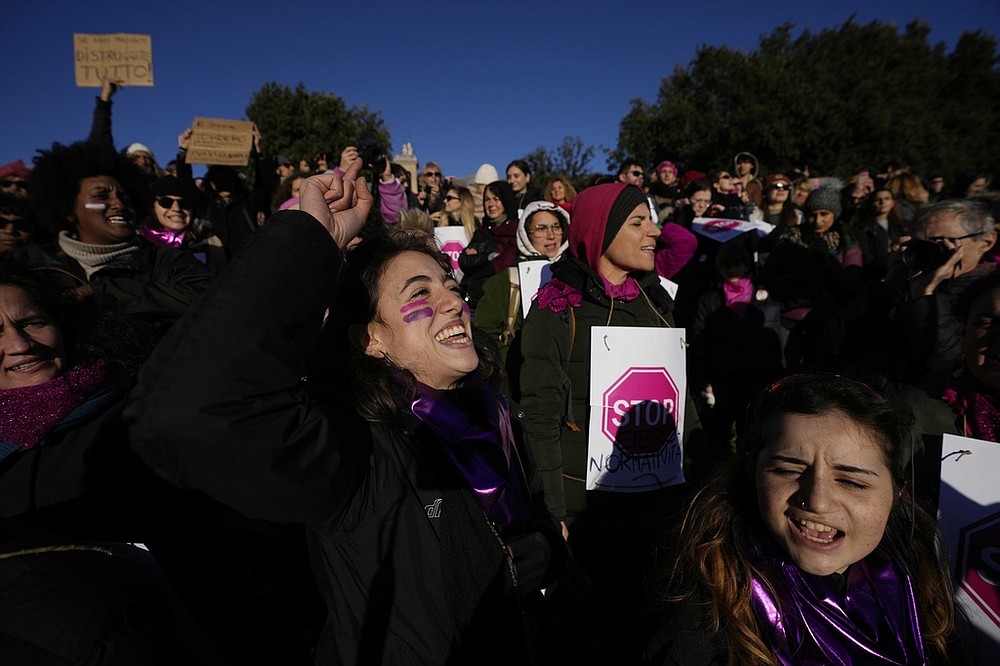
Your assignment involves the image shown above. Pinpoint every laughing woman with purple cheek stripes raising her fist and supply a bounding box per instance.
[127,167,565,664]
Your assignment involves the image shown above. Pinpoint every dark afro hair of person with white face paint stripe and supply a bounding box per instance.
[29,141,153,236]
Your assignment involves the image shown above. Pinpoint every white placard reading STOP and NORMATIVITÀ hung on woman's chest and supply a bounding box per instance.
[587,326,687,493]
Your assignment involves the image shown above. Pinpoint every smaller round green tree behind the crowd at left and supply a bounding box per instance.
[246,82,390,166]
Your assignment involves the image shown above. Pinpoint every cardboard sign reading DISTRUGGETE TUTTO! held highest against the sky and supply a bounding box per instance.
[73,32,153,88]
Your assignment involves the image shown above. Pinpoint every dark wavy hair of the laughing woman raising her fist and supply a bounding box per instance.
[312,233,501,426]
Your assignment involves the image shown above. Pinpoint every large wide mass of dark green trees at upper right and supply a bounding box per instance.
[609,20,1000,176]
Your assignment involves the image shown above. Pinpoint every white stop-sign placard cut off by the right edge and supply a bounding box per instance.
[940,435,1000,652]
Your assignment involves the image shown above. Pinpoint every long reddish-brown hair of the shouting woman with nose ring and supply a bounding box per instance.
[657,375,955,665]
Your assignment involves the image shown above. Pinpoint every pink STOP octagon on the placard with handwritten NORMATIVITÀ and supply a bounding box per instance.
[601,367,677,456]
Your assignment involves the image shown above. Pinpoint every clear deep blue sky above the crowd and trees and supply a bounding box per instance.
[0,0,1000,177]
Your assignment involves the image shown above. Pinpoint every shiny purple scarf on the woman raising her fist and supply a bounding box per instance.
[411,377,531,525]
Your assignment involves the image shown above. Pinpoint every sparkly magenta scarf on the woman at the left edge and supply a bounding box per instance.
[0,361,106,449]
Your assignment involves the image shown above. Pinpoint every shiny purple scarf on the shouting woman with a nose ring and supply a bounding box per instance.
[750,544,926,666]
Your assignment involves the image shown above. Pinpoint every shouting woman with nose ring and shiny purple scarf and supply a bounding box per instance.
[646,375,955,666]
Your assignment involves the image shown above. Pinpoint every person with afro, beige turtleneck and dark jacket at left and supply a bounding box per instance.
[8,142,212,329]
